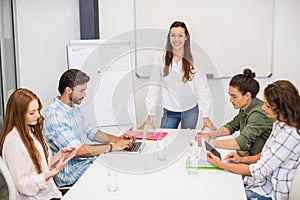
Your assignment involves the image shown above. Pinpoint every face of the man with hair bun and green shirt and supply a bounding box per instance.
[228,86,252,110]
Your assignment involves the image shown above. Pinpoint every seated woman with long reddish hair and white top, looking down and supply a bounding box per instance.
[0,88,74,199]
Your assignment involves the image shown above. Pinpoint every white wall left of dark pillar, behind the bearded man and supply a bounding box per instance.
[14,0,80,107]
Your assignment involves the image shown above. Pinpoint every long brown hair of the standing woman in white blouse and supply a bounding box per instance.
[163,21,194,82]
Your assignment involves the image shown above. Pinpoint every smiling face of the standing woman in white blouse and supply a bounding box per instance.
[170,27,187,52]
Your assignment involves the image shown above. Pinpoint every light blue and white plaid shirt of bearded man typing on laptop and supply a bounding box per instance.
[43,97,98,186]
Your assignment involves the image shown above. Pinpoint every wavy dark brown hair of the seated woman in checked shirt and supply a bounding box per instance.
[264,80,300,134]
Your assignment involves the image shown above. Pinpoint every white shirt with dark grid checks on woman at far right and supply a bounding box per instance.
[244,121,300,200]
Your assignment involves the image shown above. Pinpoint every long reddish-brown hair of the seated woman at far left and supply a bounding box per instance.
[0,88,48,174]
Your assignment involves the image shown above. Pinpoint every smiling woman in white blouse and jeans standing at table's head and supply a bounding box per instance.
[141,21,214,129]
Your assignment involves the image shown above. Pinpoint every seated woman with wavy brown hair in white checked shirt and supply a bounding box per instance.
[207,80,300,200]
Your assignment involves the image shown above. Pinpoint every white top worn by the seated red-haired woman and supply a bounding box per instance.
[2,128,62,200]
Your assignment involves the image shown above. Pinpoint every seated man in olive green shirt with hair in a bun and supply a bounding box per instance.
[198,69,274,156]
